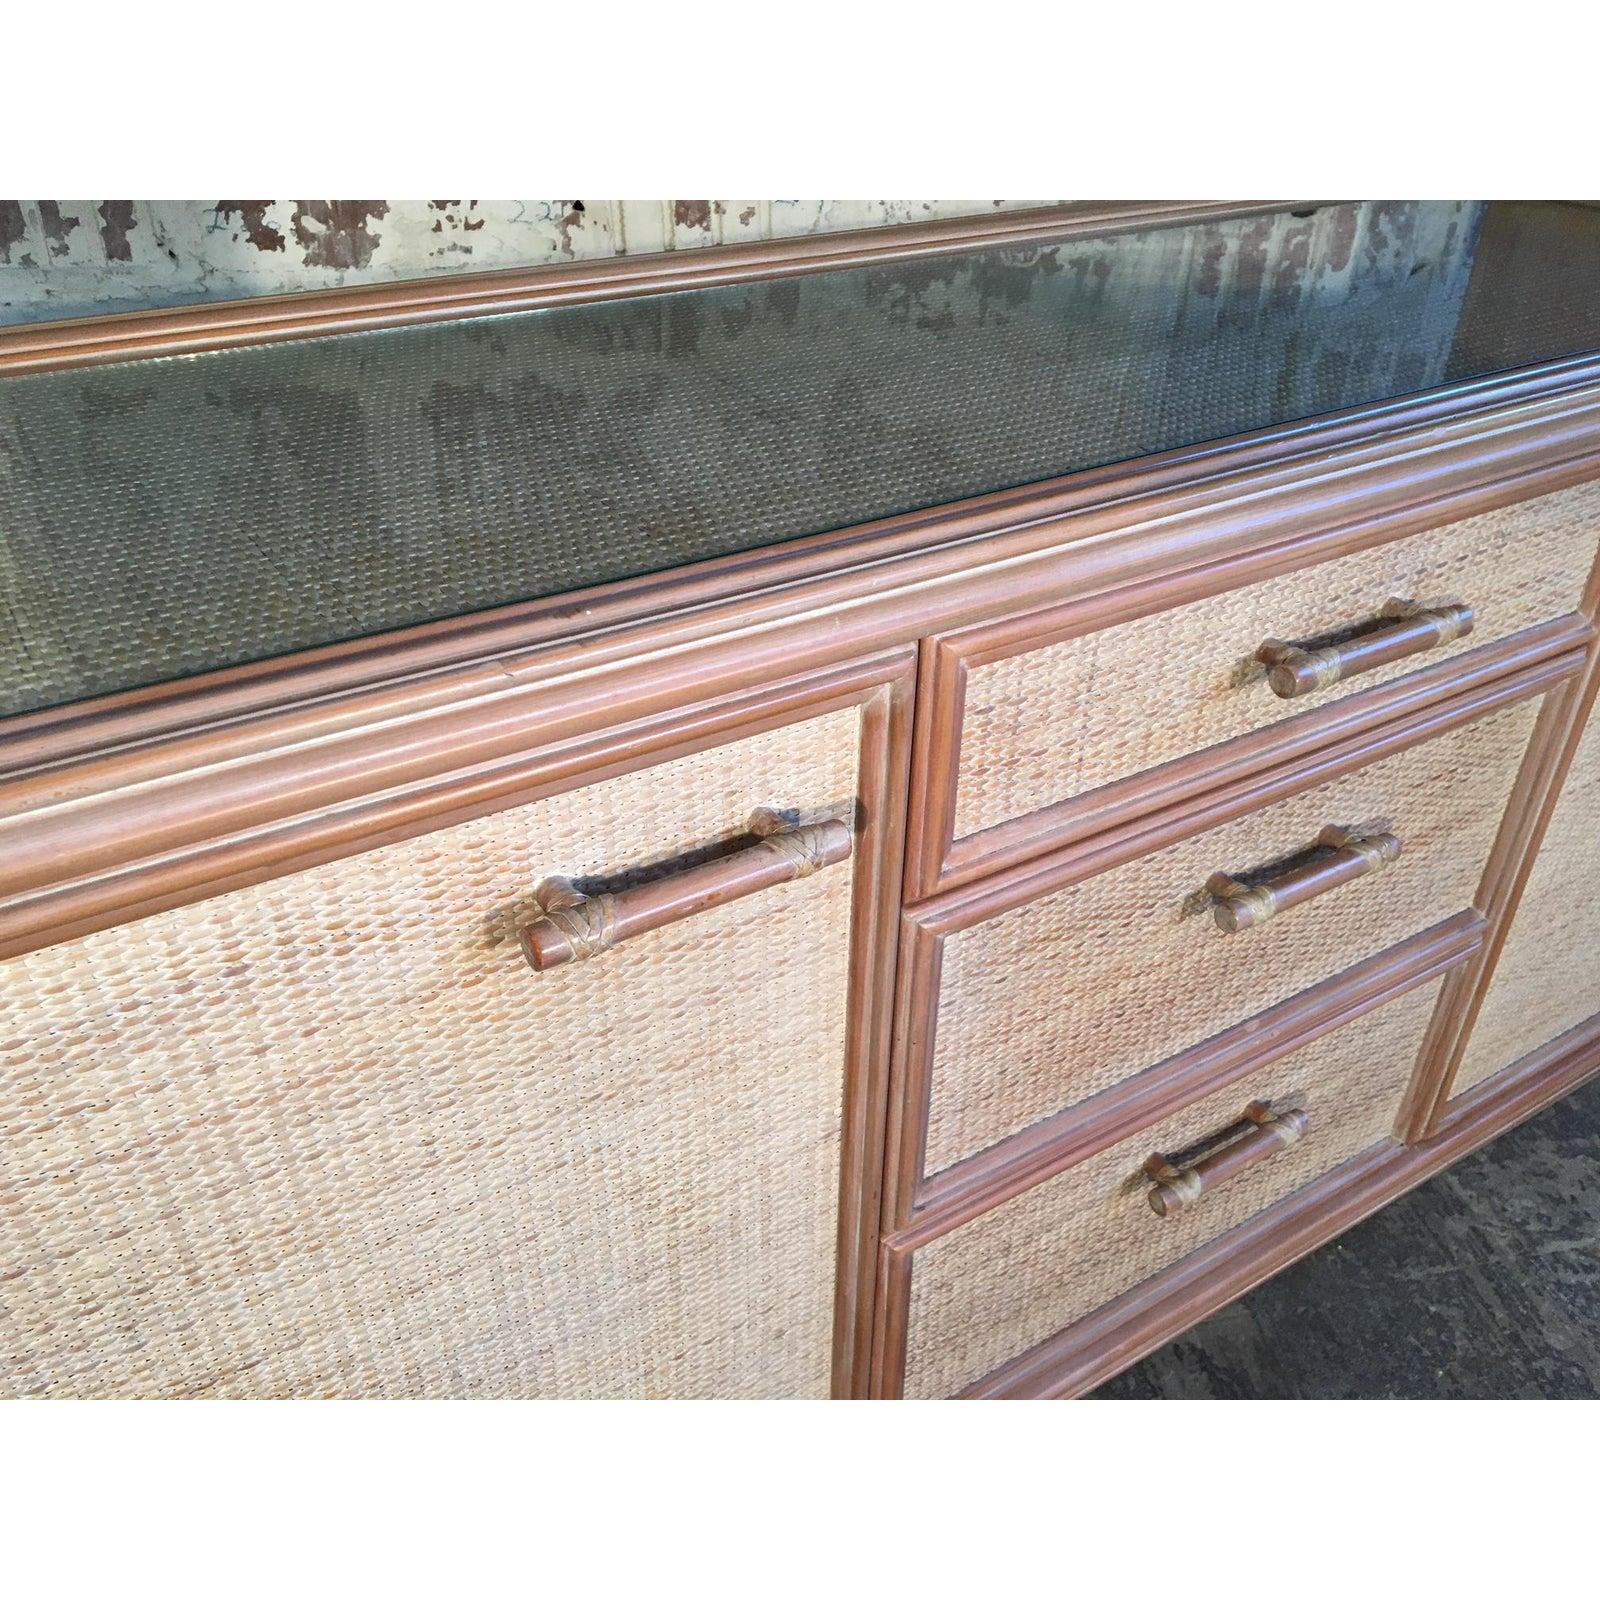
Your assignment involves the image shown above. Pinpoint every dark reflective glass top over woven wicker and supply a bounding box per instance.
[0,202,1600,714]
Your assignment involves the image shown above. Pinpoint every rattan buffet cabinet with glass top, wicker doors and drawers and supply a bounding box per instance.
[0,202,1600,1398]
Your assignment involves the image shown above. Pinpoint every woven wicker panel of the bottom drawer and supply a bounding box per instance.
[906,982,1438,1398]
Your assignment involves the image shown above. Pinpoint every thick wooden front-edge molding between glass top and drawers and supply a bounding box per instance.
[9,384,1600,955]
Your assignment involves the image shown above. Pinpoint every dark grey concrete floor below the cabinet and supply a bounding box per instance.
[1093,1080,1600,1400]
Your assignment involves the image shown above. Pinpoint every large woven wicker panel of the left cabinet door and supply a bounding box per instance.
[0,710,858,1397]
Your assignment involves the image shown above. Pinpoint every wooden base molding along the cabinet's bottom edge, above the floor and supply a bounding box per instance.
[947,1018,1600,1400]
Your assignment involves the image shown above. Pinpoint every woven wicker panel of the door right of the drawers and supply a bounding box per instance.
[1453,704,1600,1094]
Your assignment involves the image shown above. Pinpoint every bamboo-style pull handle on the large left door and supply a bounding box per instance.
[520,811,854,973]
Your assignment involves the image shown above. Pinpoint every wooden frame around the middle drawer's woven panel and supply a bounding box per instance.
[883,643,1586,1242]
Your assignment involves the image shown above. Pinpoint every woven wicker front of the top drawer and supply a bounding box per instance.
[928,483,1600,882]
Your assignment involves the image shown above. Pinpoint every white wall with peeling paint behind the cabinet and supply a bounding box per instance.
[0,200,1056,322]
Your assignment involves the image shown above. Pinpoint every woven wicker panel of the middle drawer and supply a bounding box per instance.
[928,702,1538,1173]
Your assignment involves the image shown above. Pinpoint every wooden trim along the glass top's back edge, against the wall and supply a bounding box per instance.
[0,200,1299,378]
